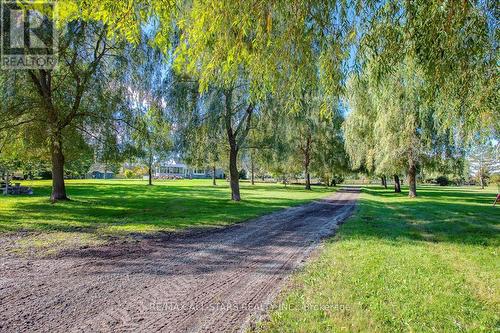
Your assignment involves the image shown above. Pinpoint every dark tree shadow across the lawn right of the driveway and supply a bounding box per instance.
[342,187,500,246]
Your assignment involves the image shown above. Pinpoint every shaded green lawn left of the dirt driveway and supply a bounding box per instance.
[0,180,332,253]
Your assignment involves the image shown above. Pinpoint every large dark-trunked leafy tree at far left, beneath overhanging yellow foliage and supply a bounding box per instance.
[2,20,129,201]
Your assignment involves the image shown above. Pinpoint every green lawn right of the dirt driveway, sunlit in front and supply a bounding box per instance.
[260,187,500,332]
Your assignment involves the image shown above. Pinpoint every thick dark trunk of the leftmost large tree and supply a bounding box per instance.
[50,132,68,202]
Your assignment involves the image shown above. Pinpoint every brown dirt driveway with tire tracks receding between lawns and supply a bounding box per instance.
[0,189,359,332]
